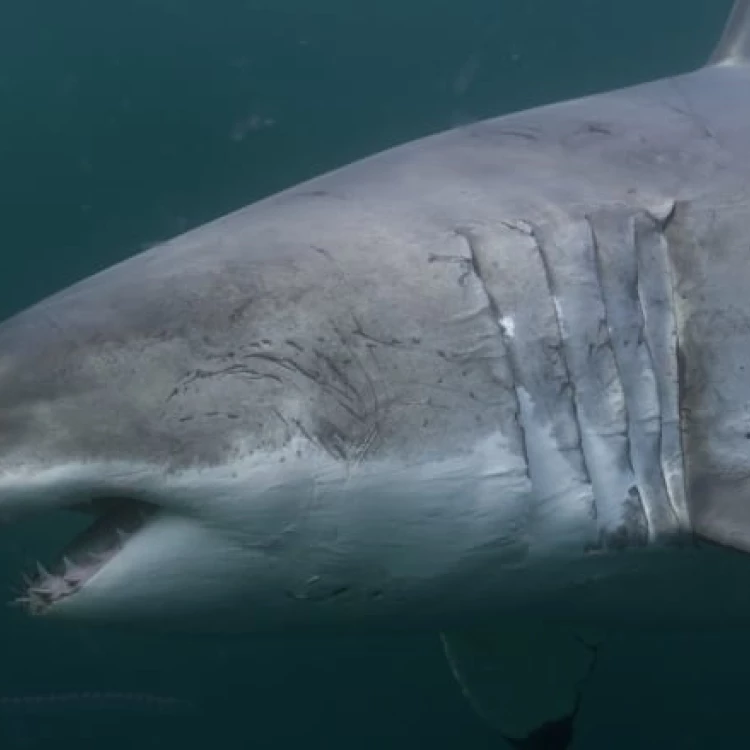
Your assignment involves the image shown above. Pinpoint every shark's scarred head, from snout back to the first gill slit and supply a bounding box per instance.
[0,207,536,629]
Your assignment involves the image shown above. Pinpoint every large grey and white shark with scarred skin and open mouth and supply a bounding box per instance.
[0,0,750,748]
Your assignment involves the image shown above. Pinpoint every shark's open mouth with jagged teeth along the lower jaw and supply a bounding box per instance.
[15,498,156,615]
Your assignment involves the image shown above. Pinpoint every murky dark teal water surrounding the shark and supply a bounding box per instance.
[0,0,750,750]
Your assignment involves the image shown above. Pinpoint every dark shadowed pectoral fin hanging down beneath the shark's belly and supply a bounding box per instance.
[442,623,600,750]
